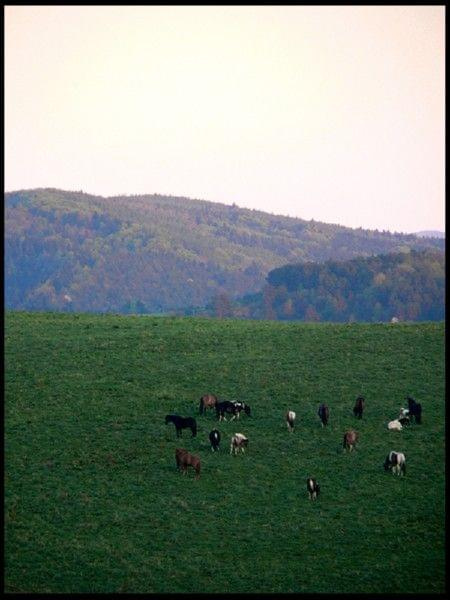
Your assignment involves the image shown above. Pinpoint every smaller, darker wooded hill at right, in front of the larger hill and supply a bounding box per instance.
[234,250,445,322]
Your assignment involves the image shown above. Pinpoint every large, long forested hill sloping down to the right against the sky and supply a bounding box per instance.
[5,189,444,313]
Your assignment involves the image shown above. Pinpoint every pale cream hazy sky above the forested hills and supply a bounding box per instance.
[5,6,445,232]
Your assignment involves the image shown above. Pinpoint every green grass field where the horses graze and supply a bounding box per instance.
[5,312,445,593]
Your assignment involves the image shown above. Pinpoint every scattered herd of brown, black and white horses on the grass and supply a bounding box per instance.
[165,394,422,500]
